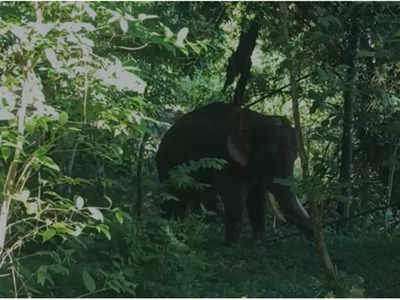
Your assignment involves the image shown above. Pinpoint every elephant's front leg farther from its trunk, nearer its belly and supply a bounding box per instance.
[219,178,247,244]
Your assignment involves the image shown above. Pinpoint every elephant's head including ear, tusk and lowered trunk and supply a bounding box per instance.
[226,108,312,237]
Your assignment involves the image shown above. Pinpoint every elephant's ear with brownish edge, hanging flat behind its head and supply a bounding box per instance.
[226,107,250,167]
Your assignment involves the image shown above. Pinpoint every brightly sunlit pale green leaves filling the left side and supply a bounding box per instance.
[0,2,192,296]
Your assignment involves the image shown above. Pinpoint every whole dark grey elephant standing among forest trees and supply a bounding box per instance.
[156,103,312,243]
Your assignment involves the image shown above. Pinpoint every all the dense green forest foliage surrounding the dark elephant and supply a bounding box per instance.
[0,2,400,297]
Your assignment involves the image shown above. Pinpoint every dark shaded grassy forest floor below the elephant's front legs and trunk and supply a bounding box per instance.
[190,223,400,298]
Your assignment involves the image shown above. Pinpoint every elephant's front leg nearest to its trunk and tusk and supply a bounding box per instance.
[247,184,266,240]
